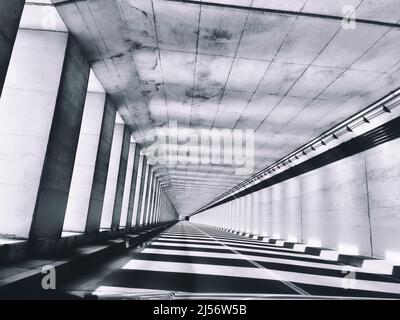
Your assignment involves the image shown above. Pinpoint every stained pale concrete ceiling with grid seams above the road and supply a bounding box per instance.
[53,0,400,214]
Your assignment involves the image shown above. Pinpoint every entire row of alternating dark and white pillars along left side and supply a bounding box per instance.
[0,0,177,239]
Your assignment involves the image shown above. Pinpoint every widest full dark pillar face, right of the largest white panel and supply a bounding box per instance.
[30,36,89,239]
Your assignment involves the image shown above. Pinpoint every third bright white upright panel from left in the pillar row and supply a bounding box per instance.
[100,123,125,229]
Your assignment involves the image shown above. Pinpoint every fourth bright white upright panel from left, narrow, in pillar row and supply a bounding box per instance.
[119,142,140,228]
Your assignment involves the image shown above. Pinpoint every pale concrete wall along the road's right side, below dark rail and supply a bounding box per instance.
[191,139,400,262]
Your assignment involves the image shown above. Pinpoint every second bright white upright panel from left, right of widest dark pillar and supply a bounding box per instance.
[63,75,106,232]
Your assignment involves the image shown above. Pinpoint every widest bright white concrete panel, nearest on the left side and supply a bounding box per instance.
[0,30,68,238]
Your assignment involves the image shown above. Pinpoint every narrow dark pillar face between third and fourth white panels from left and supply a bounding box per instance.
[111,126,131,230]
